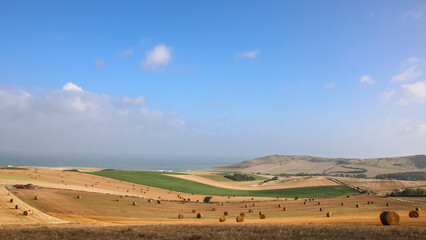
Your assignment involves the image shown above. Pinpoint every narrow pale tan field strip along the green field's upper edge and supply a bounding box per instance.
[167,174,338,190]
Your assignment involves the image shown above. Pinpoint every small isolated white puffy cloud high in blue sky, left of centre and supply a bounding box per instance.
[140,44,172,70]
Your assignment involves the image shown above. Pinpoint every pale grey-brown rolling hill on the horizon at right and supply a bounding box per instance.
[205,155,426,177]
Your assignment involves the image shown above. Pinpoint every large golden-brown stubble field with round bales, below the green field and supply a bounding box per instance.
[13,188,426,227]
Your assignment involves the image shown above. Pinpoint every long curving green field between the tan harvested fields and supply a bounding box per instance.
[88,170,358,198]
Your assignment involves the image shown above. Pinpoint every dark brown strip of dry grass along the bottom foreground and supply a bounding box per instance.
[0,224,426,240]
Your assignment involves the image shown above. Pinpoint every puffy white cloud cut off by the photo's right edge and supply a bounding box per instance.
[398,81,426,106]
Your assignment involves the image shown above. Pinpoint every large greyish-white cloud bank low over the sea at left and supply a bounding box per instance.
[0,83,186,153]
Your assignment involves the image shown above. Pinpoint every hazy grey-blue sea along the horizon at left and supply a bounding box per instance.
[0,153,246,171]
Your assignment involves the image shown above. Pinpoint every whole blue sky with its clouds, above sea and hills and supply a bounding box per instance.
[0,1,426,157]
